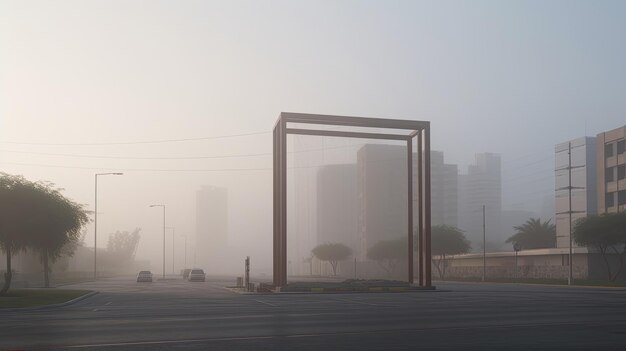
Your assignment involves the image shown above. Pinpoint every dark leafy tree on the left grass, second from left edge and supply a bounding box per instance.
[28,182,89,287]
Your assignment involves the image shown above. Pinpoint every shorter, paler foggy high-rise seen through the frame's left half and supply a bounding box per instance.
[317,164,358,251]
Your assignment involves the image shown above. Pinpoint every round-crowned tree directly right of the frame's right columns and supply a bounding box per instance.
[431,225,471,279]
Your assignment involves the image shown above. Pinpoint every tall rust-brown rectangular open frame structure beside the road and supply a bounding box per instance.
[273,112,432,288]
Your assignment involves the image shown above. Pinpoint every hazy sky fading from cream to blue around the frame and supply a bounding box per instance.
[0,0,626,272]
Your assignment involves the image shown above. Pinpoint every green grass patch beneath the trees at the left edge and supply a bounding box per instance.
[0,289,91,309]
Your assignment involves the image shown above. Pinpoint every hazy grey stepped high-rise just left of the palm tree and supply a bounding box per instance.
[459,153,500,250]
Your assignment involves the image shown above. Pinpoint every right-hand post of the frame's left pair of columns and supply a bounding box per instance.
[279,117,287,286]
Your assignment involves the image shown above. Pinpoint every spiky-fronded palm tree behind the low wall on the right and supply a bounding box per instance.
[506,218,556,250]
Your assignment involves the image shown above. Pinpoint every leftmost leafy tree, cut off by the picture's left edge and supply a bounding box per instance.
[0,173,36,295]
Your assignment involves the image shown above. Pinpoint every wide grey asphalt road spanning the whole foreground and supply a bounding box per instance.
[0,278,626,351]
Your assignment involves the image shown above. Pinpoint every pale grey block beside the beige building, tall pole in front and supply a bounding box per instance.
[554,137,598,248]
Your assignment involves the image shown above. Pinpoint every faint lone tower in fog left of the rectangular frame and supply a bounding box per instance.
[195,186,228,264]
